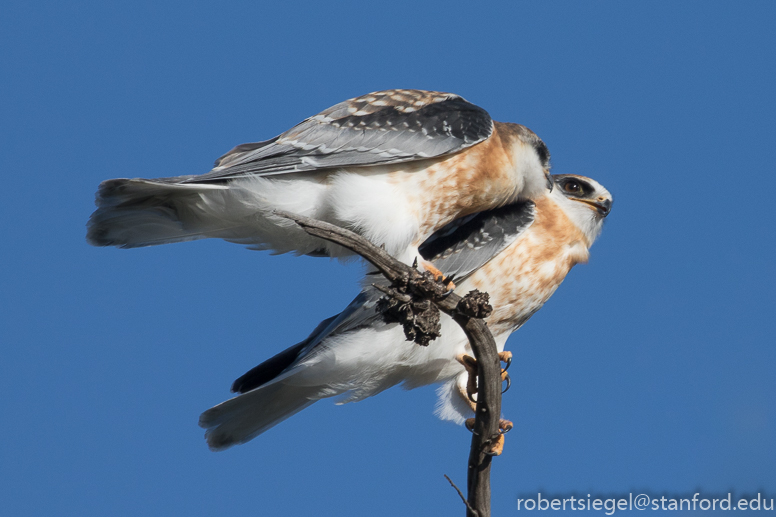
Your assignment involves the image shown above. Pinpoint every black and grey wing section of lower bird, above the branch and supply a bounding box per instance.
[418,201,536,281]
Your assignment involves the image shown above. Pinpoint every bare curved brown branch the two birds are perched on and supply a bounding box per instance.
[275,211,501,517]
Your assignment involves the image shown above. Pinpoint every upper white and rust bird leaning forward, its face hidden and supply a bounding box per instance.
[87,89,552,267]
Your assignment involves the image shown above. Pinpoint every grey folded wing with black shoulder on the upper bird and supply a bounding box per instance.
[183,90,493,183]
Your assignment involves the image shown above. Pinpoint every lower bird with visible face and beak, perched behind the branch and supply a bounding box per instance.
[199,174,613,451]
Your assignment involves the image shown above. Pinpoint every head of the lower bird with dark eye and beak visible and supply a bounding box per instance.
[552,174,614,244]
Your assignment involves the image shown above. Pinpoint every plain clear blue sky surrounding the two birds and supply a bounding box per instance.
[0,0,776,516]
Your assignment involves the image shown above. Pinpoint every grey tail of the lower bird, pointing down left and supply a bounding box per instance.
[199,382,320,451]
